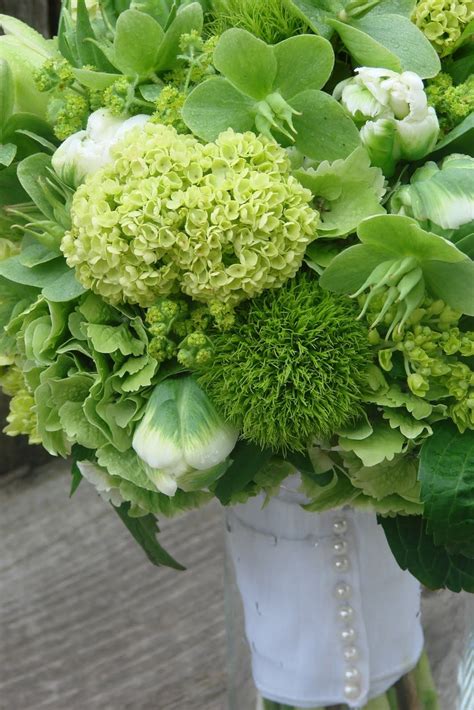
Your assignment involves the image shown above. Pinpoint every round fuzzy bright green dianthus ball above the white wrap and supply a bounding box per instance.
[199,273,371,452]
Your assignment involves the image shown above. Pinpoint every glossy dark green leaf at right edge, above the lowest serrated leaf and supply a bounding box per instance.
[420,421,474,552]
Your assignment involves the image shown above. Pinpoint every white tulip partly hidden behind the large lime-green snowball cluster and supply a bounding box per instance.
[52,109,149,187]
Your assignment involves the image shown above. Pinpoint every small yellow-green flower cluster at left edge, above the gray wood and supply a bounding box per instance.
[0,365,41,444]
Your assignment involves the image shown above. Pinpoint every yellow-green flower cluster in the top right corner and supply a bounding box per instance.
[413,0,474,57]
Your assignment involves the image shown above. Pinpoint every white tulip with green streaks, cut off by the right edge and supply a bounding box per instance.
[390,154,474,237]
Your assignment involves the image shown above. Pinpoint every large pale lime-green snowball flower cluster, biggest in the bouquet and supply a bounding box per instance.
[62,123,318,307]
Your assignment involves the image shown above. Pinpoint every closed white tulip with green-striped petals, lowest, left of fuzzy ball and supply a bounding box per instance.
[132,377,239,496]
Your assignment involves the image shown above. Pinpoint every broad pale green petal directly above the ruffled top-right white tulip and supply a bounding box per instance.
[348,13,441,79]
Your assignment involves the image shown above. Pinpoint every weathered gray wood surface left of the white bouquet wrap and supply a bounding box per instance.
[0,464,228,710]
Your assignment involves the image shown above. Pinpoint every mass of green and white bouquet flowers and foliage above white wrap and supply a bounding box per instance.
[0,0,474,707]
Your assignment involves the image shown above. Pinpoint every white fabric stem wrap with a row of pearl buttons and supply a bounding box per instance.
[227,488,423,708]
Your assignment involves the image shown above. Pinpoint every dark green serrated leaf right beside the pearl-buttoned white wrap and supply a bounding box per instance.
[379,515,474,592]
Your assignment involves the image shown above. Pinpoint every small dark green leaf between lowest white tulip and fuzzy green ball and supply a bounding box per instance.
[214,441,272,505]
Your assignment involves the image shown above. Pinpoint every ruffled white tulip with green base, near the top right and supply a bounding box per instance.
[334,67,439,176]
